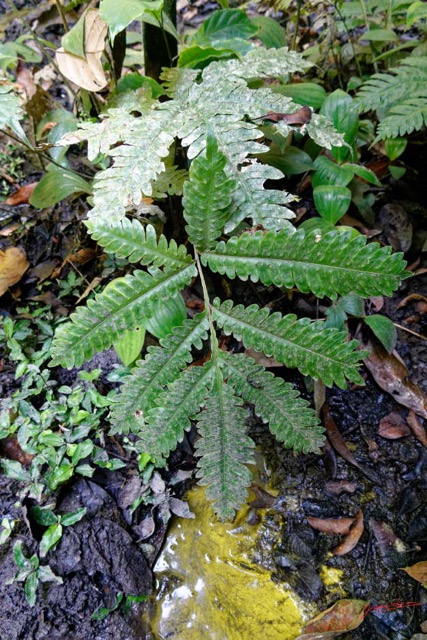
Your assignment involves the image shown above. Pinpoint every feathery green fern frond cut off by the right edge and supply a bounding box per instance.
[356,56,427,141]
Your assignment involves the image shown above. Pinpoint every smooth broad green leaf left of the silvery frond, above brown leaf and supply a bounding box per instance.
[30,168,92,209]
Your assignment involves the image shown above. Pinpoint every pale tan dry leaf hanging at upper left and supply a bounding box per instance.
[55,9,107,91]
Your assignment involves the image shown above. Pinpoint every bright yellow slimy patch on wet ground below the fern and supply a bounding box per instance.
[152,488,306,640]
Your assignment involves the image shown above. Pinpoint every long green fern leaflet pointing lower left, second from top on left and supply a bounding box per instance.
[51,264,197,368]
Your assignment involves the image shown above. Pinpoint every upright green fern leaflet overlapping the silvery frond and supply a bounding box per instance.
[182,134,236,251]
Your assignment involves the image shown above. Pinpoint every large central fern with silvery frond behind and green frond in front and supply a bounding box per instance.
[52,48,405,519]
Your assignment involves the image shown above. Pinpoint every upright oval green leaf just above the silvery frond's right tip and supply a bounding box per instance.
[320,89,359,162]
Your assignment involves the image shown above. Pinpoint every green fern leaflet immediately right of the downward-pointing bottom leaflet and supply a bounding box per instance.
[219,351,324,453]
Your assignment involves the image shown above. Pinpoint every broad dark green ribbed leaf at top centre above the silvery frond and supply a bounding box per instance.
[191,9,258,47]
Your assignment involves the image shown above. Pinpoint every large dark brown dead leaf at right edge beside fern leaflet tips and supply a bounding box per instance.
[363,341,427,418]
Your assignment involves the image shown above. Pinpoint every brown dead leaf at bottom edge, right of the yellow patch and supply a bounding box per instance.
[297,599,368,640]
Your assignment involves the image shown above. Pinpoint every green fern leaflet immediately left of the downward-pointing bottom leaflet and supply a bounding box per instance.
[138,360,214,466]
